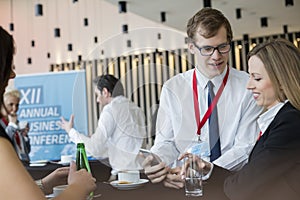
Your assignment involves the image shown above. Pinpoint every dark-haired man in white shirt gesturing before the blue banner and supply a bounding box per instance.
[61,74,147,181]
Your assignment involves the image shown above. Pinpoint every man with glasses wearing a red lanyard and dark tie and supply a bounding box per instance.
[143,8,261,188]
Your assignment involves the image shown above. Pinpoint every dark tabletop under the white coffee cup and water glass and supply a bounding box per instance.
[26,161,228,200]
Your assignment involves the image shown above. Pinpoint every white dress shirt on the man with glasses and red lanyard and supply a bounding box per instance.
[151,68,262,170]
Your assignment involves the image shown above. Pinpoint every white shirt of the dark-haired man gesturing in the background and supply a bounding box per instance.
[69,96,146,171]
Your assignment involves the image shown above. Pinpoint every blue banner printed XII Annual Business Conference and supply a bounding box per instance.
[14,71,88,161]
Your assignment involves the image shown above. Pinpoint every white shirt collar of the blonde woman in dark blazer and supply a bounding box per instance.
[257,100,288,133]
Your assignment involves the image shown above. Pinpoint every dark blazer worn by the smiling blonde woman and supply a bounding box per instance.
[224,102,300,200]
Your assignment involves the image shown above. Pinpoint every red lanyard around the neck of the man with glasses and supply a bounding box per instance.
[193,67,229,136]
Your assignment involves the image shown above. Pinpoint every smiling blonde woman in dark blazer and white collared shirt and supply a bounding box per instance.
[224,39,300,200]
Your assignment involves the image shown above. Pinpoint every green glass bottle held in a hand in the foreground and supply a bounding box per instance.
[76,143,94,199]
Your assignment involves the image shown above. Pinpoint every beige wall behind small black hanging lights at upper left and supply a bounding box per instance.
[0,0,185,74]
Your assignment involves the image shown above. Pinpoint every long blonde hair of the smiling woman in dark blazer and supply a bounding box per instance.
[248,38,300,110]
